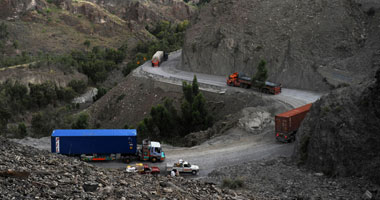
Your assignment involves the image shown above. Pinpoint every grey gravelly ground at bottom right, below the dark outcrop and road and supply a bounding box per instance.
[202,158,380,200]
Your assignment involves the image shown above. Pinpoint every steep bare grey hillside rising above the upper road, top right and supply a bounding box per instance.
[182,0,380,90]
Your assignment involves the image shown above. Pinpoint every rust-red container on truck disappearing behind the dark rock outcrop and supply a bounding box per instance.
[275,103,312,142]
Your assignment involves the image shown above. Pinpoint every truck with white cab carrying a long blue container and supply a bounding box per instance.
[51,129,165,162]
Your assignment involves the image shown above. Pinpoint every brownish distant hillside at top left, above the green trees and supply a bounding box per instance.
[0,0,194,54]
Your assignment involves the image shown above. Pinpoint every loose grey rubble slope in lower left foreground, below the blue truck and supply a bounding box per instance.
[0,137,252,199]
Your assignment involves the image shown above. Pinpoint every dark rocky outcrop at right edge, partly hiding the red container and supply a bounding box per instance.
[295,67,380,183]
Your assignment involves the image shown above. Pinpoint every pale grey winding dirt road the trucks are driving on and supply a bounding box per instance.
[17,51,322,177]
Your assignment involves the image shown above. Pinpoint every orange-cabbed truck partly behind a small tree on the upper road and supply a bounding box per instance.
[227,72,281,95]
